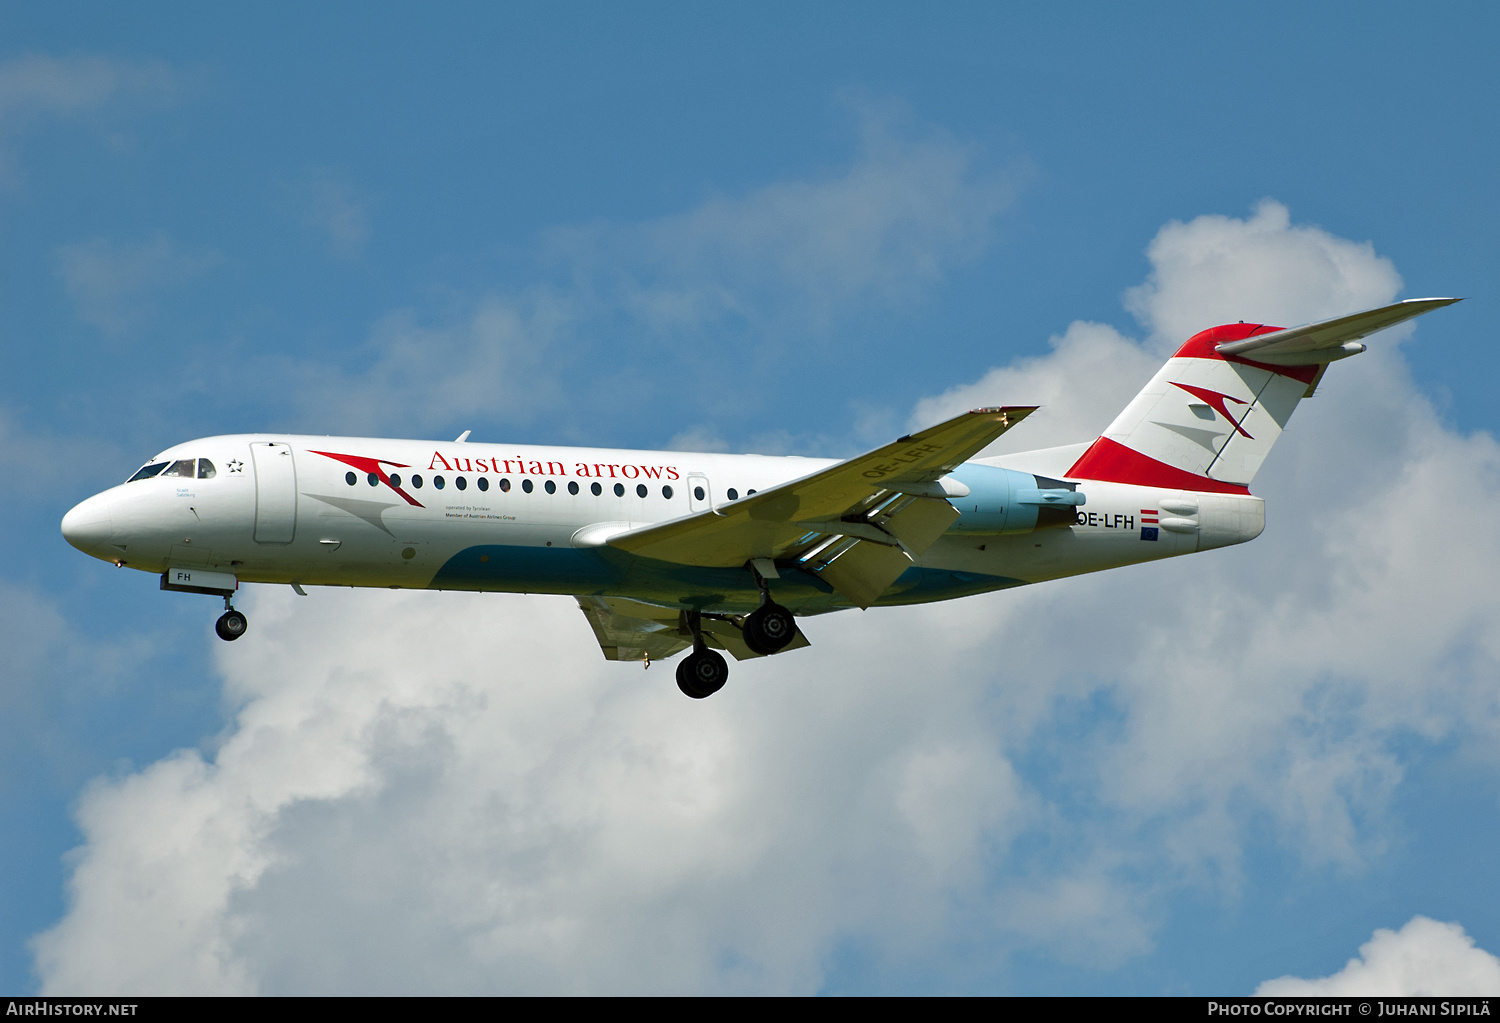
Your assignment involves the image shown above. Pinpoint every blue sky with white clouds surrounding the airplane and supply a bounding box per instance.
[0,3,1500,993]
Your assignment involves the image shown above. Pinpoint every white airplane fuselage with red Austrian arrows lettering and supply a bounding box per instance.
[63,435,1265,614]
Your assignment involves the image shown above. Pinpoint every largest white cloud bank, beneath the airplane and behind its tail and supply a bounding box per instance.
[38,199,1500,993]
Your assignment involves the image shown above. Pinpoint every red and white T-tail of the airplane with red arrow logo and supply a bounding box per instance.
[1067,299,1460,494]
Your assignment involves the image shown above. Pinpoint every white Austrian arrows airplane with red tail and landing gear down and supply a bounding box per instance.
[62,299,1458,699]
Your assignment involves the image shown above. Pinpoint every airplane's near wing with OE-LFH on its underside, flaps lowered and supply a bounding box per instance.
[608,405,1037,608]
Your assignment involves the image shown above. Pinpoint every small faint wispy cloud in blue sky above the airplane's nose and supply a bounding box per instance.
[53,236,219,338]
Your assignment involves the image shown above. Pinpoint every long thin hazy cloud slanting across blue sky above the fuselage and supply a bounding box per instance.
[300,101,1022,429]
